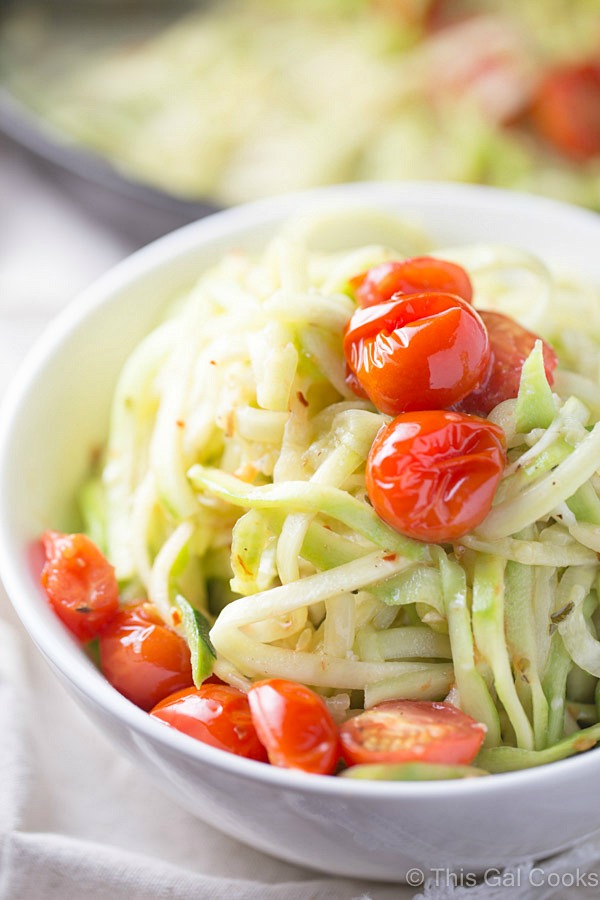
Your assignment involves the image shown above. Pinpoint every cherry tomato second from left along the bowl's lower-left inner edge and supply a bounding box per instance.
[100,603,193,710]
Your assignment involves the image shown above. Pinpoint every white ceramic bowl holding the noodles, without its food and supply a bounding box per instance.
[0,183,600,880]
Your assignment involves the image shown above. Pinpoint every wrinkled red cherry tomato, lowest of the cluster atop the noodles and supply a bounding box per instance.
[366,410,506,543]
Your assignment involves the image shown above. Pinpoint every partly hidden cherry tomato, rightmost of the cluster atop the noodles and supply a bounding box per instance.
[455,310,558,416]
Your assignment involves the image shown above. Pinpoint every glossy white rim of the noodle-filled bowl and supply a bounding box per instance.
[0,181,600,800]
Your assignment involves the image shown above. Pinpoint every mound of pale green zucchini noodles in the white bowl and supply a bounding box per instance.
[80,210,600,771]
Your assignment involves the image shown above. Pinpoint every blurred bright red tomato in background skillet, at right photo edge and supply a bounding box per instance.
[531,60,600,162]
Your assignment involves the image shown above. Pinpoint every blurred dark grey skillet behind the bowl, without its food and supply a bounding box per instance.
[0,0,218,244]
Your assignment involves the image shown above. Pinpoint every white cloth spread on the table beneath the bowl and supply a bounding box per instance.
[0,144,600,900]
